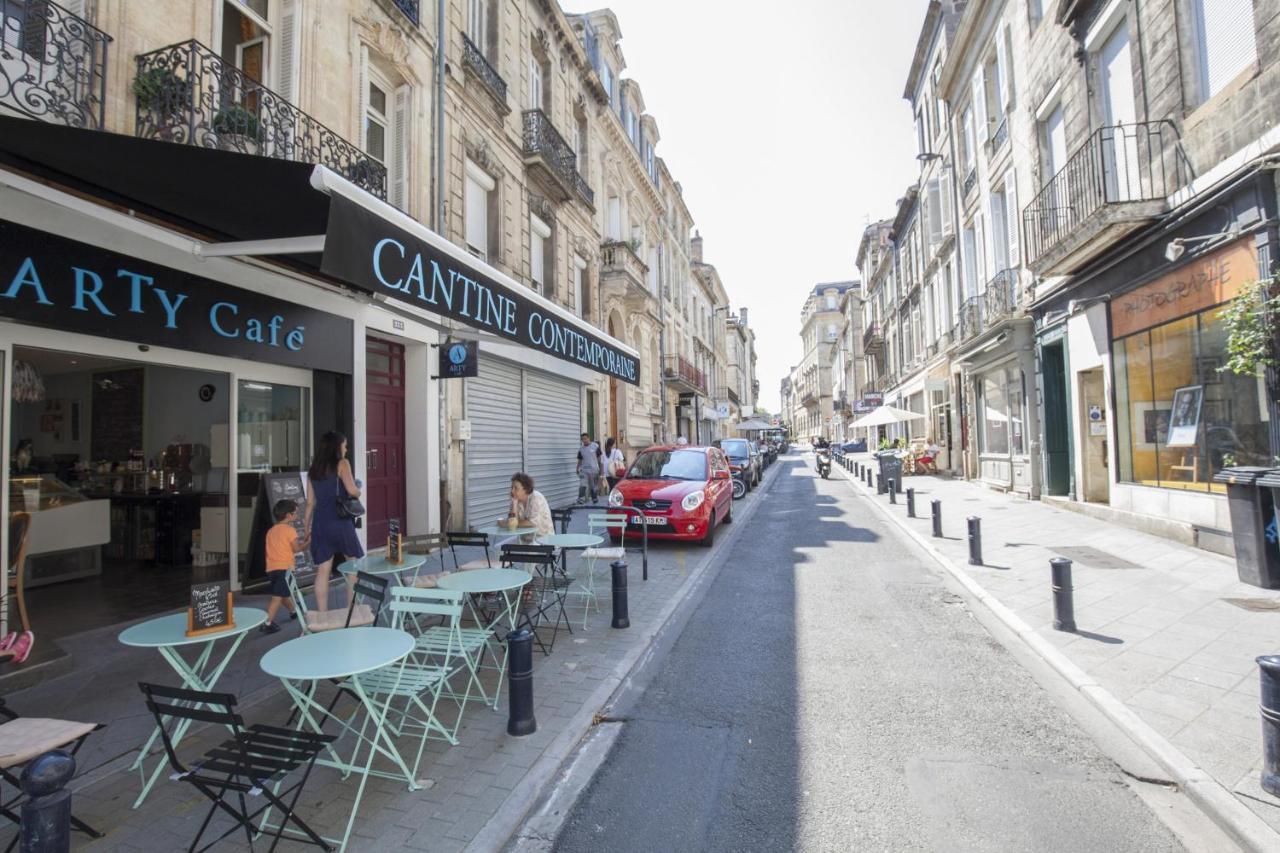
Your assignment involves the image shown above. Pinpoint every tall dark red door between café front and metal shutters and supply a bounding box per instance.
[365,338,408,540]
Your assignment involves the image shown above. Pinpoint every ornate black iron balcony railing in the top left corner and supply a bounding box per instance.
[0,0,111,131]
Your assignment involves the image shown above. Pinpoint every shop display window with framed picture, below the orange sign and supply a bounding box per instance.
[1112,306,1271,492]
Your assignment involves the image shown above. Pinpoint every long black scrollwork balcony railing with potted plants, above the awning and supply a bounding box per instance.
[132,40,387,199]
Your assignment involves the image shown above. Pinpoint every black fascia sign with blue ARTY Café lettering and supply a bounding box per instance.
[0,220,352,373]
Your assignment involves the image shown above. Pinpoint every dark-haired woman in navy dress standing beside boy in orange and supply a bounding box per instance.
[306,432,365,611]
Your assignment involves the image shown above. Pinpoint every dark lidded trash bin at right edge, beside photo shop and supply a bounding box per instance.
[1213,465,1280,589]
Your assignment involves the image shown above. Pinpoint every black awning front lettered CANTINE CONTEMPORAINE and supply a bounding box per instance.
[320,196,640,386]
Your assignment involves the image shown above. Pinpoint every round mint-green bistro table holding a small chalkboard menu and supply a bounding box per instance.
[118,607,266,808]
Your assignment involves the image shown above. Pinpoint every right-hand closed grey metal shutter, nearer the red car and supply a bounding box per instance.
[525,370,582,507]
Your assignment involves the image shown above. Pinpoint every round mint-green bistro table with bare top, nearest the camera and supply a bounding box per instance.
[261,628,419,850]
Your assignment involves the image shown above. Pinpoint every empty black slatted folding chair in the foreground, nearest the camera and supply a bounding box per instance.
[138,683,337,852]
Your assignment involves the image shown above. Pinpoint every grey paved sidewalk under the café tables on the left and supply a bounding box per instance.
[0,469,776,853]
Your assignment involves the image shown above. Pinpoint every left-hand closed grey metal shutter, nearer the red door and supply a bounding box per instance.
[463,357,522,529]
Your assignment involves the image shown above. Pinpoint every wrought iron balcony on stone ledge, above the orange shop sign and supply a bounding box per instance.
[1023,119,1192,275]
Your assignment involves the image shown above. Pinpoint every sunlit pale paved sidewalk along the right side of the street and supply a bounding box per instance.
[835,455,1280,849]
